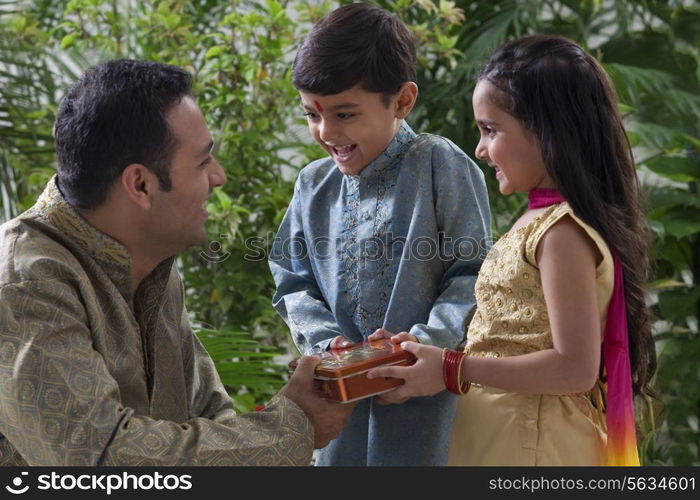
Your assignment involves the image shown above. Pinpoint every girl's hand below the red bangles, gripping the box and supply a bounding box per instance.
[367,342,445,403]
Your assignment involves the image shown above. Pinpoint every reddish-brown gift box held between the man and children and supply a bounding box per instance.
[290,339,416,403]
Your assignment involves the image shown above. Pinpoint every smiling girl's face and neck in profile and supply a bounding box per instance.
[472,80,555,195]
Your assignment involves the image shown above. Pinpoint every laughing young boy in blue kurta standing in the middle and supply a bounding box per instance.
[270,3,490,466]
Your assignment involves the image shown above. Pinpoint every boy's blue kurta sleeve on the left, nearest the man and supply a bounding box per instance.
[269,181,343,354]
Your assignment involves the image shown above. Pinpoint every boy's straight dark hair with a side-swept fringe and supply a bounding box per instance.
[292,3,416,103]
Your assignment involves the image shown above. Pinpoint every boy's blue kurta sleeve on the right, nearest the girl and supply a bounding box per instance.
[410,151,491,348]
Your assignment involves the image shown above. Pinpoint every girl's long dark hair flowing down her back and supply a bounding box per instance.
[478,35,656,395]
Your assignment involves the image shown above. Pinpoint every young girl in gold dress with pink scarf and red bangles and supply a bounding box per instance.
[370,36,656,465]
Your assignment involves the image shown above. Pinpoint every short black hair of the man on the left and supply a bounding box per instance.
[54,59,192,209]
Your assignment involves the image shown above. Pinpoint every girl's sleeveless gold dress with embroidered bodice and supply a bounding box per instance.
[448,203,614,466]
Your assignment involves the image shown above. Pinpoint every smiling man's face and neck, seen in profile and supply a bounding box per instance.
[149,97,226,255]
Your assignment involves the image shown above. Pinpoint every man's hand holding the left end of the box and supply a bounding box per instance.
[279,356,355,449]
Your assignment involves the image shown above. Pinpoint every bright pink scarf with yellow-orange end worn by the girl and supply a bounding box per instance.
[528,188,639,466]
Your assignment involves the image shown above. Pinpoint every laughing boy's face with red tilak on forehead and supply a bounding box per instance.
[299,85,410,175]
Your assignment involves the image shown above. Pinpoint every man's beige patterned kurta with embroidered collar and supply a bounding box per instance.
[0,179,313,466]
